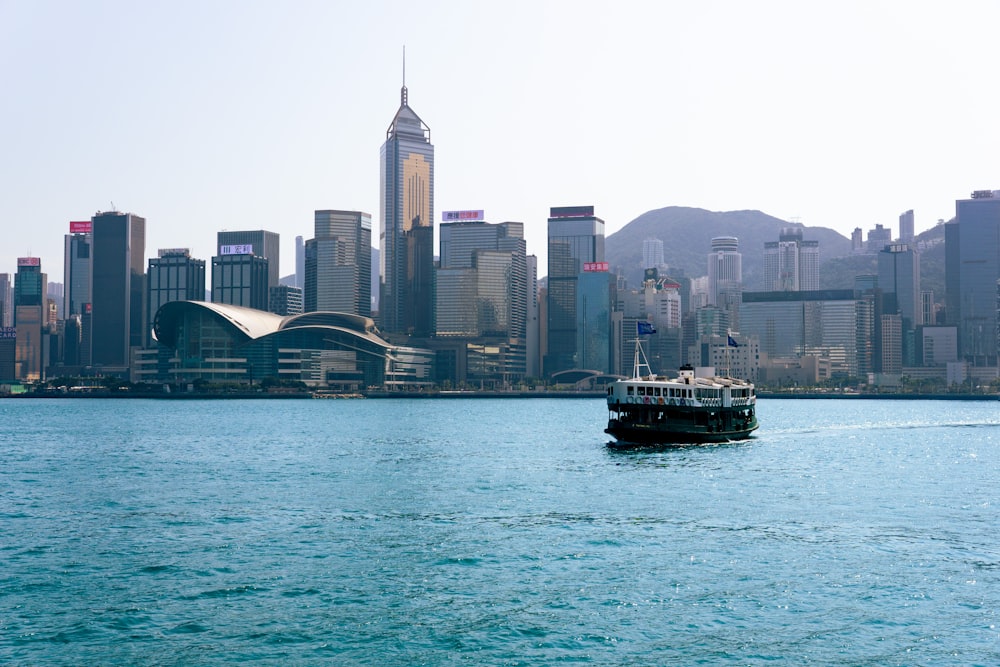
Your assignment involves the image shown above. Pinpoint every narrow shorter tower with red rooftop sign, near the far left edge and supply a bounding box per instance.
[14,257,48,380]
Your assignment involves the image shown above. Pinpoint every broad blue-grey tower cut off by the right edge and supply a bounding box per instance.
[945,190,1000,366]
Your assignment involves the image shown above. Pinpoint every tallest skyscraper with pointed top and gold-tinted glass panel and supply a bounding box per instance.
[378,82,434,336]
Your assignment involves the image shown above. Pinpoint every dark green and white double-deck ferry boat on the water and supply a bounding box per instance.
[604,339,757,447]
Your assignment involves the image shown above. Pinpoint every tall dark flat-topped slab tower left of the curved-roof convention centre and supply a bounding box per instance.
[92,211,146,372]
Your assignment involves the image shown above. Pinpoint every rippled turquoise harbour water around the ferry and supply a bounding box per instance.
[0,399,1000,666]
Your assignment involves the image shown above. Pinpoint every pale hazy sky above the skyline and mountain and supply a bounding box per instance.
[0,0,1000,281]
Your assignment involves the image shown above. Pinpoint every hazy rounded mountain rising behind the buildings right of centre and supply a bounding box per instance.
[605,206,852,291]
